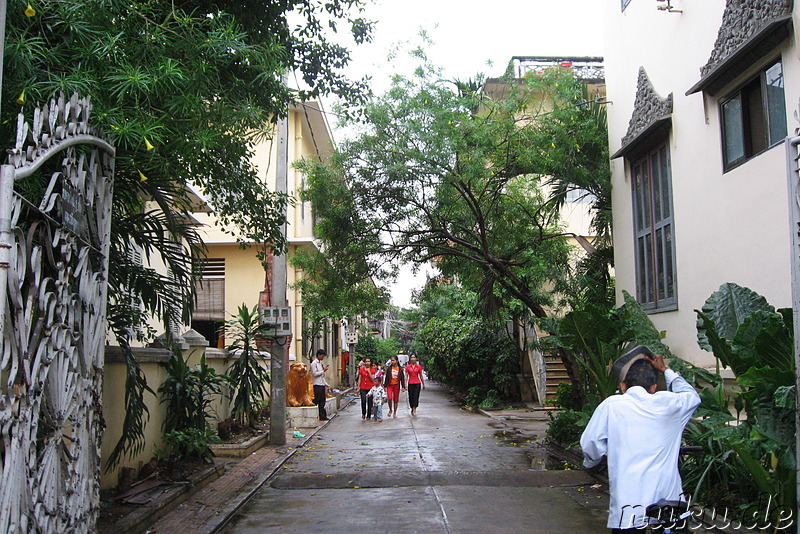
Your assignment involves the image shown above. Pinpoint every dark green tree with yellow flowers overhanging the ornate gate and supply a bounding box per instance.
[0,0,371,465]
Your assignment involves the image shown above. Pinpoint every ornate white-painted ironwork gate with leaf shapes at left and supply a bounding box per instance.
[0,95,114,532]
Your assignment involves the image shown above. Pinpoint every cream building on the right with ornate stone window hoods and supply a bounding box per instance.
[605,0,800,366]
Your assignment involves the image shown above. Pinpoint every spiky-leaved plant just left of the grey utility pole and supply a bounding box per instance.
[224,303,274,425]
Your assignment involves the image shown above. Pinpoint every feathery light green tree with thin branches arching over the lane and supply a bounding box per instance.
[294,53,600,322]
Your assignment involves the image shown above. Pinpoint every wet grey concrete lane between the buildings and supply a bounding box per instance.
[222,384,608,534]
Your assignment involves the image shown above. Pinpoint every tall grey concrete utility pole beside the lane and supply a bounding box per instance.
[269,105,291,445]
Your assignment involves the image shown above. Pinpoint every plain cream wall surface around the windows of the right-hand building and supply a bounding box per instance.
[605,0,800,366]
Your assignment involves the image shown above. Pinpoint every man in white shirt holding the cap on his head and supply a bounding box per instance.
[581,346,700,534]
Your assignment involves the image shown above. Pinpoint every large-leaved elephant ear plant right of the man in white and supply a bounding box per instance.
[696,283,797,524]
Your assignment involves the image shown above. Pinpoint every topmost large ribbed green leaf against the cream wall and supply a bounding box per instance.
[697,282,775,351]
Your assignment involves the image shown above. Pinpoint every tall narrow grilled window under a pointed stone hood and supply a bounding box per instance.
[632,142,678,311]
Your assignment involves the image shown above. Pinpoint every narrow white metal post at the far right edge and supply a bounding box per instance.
[786,136,800,517]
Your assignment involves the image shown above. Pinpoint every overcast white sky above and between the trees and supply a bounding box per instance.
[322,0,607,307]
